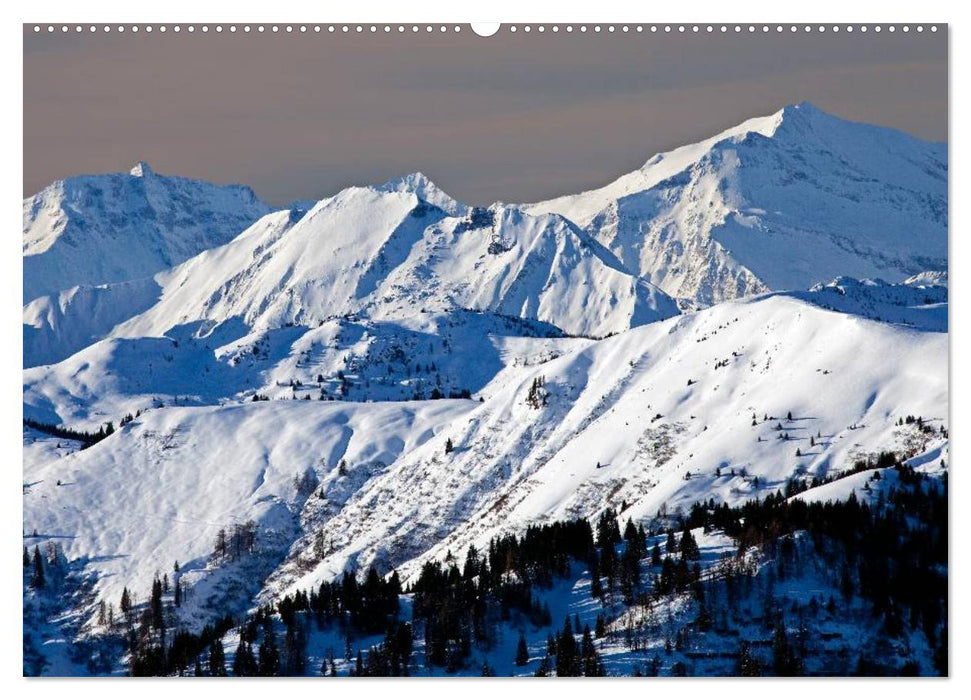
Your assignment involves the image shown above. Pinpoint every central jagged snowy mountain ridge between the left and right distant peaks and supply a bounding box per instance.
[24,174,678,366]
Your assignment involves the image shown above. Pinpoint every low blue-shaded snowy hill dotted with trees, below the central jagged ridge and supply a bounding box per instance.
[23,311,590,431]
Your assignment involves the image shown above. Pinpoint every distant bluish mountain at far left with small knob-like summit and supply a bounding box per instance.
[23,163,270,303]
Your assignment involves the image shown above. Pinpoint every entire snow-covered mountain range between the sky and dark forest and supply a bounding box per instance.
[23,104,949,673]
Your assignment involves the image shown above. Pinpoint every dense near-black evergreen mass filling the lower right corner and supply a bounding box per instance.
[686,458,948,675]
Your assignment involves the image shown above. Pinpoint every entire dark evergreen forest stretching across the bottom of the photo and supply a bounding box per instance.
[23,453,948,676]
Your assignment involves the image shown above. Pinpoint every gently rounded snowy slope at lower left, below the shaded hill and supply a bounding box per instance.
[24,401,474,610]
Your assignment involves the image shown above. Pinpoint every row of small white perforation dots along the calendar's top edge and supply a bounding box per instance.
[28,24,938,34]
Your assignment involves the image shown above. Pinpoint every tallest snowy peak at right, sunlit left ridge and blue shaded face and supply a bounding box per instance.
[525,103,947,307]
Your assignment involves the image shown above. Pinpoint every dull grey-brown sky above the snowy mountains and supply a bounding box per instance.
[24,27,947,204]
